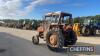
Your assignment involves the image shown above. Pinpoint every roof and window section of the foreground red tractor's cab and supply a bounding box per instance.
[45,12,72,24]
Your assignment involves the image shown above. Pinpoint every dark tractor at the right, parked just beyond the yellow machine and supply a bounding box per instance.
[81,18,100,36]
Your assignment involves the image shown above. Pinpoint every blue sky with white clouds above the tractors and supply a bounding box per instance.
[0,0,100,19]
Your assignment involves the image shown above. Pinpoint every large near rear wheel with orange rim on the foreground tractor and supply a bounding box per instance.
[46,30,64,51]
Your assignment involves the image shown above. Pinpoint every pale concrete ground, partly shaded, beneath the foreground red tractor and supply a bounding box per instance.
[0,27,100,56]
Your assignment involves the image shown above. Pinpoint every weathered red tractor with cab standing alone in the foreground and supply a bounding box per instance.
[32,11,77,50]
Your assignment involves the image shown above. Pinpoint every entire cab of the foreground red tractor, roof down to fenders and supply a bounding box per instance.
[44,12,72,29]
